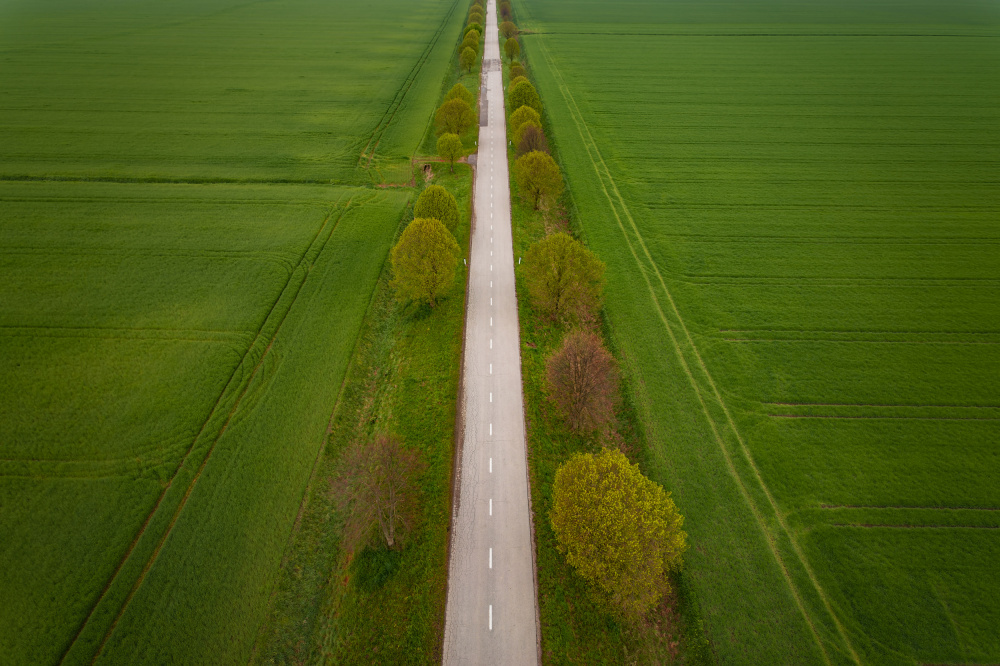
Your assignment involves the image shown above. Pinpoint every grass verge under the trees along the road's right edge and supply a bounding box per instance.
[503,23,715,664]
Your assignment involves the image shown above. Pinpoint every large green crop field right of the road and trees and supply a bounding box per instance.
[515,0,1000,664]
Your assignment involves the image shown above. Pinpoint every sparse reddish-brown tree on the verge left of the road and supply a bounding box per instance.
[334,435,424,552]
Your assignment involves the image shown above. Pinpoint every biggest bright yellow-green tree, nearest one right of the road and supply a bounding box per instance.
[549,449,687,621]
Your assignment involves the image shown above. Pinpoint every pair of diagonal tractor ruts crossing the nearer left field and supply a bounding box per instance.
[59,193,353,664]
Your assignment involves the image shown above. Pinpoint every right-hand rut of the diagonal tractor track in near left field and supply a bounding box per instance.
[85,198,353,664]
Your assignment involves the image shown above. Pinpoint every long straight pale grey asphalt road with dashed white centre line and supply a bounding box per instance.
[444,0,538,665]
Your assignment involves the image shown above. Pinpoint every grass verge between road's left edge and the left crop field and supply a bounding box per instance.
[254,164,472,664]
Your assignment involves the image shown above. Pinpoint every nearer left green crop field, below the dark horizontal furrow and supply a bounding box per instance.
[0,183,407,663]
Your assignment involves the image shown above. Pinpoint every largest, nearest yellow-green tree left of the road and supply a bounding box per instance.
[392,217,461,307]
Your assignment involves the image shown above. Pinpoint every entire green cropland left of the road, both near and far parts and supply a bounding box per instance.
[0,0,465,664]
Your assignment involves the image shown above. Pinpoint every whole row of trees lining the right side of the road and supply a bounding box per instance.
[500,0,687,623]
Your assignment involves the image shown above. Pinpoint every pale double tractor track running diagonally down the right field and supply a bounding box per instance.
[539,40,861,664]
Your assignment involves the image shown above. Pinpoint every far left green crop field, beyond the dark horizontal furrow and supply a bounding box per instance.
[0,0,464,182]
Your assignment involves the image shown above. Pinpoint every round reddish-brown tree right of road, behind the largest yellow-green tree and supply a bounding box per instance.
[545,331,618,432]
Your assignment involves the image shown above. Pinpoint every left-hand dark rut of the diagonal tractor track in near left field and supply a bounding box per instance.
[58,191,351,664]
